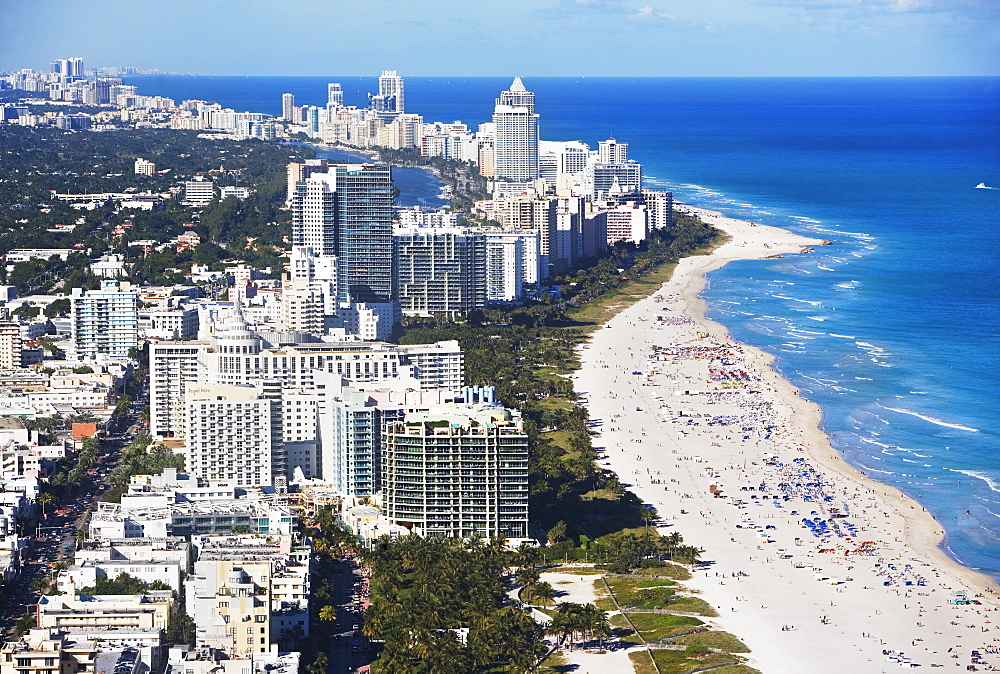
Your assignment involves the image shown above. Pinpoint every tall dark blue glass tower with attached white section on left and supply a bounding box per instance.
[292,164,396,303]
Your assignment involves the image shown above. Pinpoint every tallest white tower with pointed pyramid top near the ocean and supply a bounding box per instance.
[493,77,538,181]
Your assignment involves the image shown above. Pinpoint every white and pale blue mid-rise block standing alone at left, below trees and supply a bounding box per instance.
[70,281,139,358]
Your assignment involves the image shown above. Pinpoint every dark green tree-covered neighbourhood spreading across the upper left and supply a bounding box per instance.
[0,125,315,293]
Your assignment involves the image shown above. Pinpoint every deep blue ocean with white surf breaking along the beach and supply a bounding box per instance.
[129,73,1000,576]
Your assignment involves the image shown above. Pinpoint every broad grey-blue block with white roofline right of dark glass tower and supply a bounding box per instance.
[394,227,486,316]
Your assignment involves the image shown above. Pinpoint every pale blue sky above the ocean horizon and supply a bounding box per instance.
[0,0,1000,77]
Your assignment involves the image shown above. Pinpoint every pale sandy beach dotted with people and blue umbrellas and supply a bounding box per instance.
[574,206,1000,674]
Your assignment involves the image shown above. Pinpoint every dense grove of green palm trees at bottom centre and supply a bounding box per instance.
[364,536,544,674]
